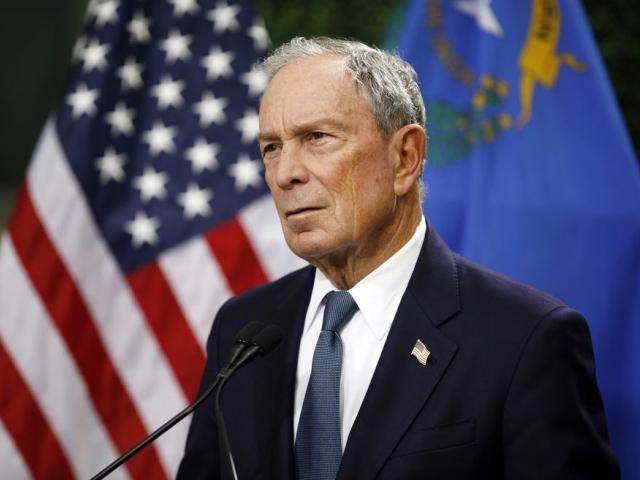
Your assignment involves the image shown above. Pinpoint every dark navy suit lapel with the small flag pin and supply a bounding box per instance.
[338,228,459,479]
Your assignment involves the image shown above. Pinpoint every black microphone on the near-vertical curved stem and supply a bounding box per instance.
[214,325,283,480]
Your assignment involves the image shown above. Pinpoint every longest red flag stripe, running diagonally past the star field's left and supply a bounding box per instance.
[9,184,167,480]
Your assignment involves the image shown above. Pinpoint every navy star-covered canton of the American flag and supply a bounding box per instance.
[57,0,268,272]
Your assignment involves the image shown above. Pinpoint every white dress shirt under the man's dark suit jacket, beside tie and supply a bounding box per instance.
[293,217,427,452]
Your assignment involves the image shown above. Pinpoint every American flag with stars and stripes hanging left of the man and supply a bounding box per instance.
[0,0,300,479]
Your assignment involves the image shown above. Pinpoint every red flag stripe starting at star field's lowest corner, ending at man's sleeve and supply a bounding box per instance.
[128,262,205,400]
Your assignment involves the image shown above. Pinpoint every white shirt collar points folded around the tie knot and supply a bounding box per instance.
[303,217,427,340]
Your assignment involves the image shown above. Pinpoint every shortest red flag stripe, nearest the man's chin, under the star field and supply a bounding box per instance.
[205,218,267,295]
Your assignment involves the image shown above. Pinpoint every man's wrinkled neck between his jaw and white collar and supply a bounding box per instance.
[309,198,422,290]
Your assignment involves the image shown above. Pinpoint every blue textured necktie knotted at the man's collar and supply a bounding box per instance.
[295,291,358,480]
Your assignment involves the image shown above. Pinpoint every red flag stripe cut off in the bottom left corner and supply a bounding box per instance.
[0,340,74,478]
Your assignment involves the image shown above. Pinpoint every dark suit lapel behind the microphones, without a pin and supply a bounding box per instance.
[255,267,315,480]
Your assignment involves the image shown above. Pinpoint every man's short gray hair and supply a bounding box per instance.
[262,37,426,138]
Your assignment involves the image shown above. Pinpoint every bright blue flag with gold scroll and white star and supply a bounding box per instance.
[397,0,640,478]
